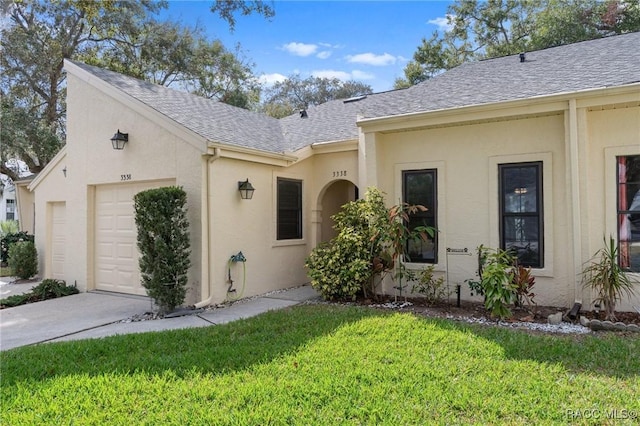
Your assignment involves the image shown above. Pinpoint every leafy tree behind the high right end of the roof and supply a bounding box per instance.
[395,0,640,88]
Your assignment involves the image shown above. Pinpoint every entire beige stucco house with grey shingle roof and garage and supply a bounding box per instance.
[20,33,640,310]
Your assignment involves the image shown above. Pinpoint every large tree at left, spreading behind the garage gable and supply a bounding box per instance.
[0,0,274,179]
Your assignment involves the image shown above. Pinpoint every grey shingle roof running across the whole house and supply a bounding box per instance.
[67,32,640,152]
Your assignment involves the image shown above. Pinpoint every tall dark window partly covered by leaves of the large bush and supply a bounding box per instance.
[402,169,438,263]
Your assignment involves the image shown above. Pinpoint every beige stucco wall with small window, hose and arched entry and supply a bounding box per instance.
[202,149,357,302]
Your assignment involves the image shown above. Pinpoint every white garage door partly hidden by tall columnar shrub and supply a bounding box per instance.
[94,181,175,295]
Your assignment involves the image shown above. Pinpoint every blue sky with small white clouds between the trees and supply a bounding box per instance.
[162,0,450,92]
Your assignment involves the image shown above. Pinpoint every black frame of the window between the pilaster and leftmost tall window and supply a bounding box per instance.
[498,161,545,269]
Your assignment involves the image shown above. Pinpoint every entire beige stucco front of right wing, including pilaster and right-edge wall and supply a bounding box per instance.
[360,93,640,310]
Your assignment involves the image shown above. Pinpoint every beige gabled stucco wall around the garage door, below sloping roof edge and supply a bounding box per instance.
[35,74,204,302]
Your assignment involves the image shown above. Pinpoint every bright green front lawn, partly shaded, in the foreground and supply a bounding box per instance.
[0,305,640,425]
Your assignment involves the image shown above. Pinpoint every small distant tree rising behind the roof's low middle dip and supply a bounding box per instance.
[263,75,373,118]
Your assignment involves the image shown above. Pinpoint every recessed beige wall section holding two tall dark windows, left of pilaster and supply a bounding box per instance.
[368,113,574,306]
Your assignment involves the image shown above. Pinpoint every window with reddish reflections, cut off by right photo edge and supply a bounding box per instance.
[617,155,640,272]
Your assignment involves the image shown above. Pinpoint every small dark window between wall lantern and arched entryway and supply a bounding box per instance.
[277,178,302,240]
